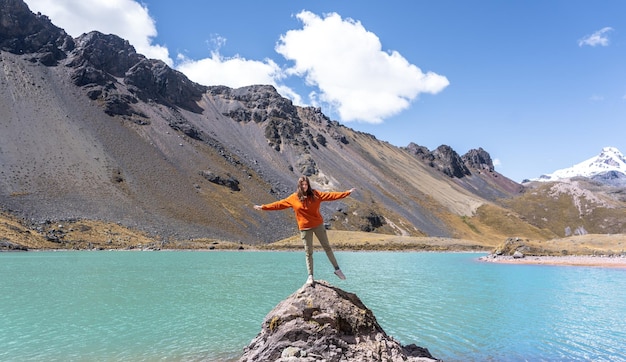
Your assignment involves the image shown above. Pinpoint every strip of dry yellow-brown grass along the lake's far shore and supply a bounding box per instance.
[0,214,626,256]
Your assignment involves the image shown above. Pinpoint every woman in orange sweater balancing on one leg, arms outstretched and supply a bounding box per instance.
[254,176,355,284]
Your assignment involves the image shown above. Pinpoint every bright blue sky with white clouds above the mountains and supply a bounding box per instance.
[26,0,626,182]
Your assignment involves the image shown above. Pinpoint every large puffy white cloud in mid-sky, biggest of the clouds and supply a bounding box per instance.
[276,11,449,123]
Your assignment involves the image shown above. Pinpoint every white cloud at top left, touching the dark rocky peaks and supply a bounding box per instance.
[26,0,173,66]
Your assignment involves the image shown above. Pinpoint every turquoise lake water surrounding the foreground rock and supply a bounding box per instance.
[0,251,626,361]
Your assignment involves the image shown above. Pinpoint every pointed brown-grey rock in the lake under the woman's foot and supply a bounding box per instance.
[239,281,436,362]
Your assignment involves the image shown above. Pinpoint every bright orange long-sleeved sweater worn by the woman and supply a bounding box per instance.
[261,190,350,230]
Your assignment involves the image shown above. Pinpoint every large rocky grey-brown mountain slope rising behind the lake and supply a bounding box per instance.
[0,0,626,243]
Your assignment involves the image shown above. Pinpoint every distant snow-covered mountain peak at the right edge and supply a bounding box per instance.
[531,147,626,184]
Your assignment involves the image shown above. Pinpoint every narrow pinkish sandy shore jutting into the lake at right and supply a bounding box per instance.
[479,255,626,268]
